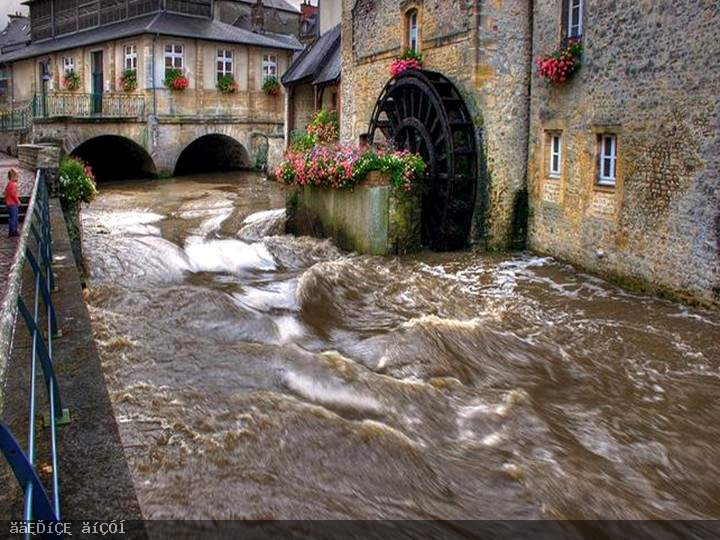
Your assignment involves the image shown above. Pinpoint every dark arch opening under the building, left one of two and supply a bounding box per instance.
[66,135,157,182]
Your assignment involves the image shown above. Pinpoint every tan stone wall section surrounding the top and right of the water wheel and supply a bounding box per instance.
[341,0,531,248]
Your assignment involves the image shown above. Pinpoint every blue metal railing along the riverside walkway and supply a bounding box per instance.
[0,171,69,532]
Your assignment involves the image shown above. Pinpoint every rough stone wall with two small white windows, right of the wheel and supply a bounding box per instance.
[528,0,720,303]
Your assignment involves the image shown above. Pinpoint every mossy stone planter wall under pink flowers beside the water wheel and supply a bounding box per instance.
[287,171,422,255]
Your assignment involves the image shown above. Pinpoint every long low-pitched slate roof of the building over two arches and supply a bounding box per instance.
[0,12,302,62]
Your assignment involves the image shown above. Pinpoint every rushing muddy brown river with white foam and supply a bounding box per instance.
[84,173,720,519]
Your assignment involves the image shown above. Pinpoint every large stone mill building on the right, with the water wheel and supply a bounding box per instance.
[341,0,720,303]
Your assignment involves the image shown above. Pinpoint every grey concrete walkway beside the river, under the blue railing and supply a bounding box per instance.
[0,195,146,538]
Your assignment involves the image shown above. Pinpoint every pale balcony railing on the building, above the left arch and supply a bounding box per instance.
[33,92,145,119]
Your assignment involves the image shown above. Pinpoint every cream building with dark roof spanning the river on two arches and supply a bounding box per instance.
[0,0,301,174]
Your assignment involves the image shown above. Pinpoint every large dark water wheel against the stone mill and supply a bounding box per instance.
[368,70,478,251]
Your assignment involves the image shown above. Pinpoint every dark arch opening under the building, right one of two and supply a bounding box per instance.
[175,133,252,176]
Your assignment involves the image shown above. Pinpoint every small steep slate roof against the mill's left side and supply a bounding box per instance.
[282,25,341,86]
